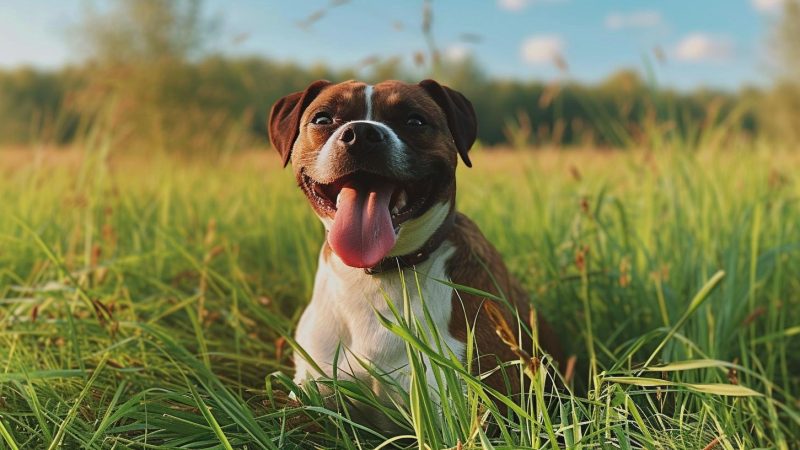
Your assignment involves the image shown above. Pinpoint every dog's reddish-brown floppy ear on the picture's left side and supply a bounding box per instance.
[268,80,331,167]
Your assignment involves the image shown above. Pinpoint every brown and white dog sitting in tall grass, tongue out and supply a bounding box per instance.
[269,80,560,418]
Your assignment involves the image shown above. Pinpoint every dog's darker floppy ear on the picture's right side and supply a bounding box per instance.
[419,80,478,167]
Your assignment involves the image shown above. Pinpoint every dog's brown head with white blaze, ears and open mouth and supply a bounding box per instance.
[269,80,477,267]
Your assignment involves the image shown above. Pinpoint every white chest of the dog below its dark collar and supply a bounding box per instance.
[295,242,464,387]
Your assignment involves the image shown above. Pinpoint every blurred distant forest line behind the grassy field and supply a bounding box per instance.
[0,57,764,151]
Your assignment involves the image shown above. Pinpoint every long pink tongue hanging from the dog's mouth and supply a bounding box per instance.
[328,183,397,268]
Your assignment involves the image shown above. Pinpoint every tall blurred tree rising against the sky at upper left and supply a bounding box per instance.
[70,0,225,151]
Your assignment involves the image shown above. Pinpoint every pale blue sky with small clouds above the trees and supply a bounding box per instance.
[0,0,783,90]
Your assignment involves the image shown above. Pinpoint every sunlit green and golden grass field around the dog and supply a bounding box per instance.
[0,142,800,449]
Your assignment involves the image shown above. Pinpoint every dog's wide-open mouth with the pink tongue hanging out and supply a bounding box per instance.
[302,172,435,267]
